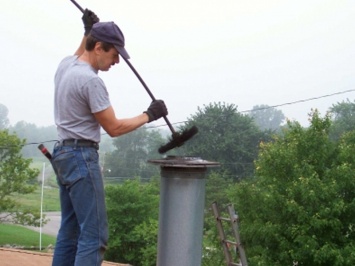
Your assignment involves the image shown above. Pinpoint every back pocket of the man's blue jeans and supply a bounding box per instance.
[52,151,82,187]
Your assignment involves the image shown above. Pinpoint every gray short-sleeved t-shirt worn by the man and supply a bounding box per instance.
[54,56,111,142]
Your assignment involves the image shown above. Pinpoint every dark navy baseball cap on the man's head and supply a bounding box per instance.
[90,21,130,59]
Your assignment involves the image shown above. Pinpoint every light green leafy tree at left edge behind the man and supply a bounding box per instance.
[0,130,40,226]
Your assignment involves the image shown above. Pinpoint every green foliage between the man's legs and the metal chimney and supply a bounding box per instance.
[105,180,159,266]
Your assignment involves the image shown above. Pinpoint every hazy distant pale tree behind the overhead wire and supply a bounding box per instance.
[249,104,285,131]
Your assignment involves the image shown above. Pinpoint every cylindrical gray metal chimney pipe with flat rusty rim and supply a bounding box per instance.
[148,156,219,266]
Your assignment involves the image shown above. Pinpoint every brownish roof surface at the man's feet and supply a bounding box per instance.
[0,248,129,266]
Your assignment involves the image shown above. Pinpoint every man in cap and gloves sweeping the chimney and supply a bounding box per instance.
[51,10,168,266]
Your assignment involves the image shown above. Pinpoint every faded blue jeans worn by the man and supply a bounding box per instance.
[51,145,108,266]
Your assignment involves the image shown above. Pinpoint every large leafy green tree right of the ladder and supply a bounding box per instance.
[229,111,355,266]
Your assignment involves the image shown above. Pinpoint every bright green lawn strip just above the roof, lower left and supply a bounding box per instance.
[0,224,56,249]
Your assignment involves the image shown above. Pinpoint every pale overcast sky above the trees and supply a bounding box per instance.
[0,0,355,129]
